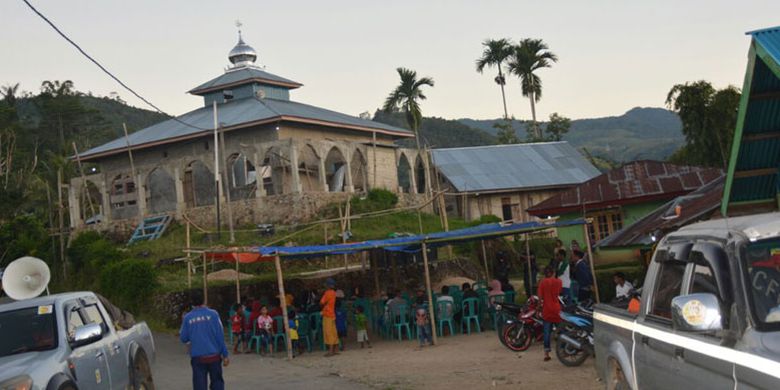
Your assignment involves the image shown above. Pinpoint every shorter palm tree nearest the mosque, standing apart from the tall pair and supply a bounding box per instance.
[383,68,433,151]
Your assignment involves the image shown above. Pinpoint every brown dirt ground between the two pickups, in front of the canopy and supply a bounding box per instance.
[154,331,603,390]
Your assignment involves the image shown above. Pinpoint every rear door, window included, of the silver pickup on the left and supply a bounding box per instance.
[83,300,130,389]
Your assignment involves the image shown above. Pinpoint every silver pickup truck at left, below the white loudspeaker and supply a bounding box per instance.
[0,292,155,390]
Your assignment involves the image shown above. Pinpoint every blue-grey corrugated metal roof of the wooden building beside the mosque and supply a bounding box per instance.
[433,142,599,192]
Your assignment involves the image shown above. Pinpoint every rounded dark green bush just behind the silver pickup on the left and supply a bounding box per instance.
[98,259,158,312]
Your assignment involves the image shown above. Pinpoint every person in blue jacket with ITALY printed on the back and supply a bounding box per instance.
[179,291,230,390]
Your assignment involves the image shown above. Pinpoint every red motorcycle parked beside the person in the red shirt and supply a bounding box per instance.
[497,296,544,352]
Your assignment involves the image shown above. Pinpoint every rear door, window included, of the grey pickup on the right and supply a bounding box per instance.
[634,260,686,389]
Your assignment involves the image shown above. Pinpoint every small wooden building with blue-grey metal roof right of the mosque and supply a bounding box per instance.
[432,142,599,222]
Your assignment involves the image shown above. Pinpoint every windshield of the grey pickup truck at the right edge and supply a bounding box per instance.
[743,238,780,325]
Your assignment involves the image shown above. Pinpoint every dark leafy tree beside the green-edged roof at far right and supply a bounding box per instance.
[666,80,740,168]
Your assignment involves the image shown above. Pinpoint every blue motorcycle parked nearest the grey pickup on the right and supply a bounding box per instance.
[555,306,594,367]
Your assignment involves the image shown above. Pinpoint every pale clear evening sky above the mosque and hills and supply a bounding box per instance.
[0,0,780,119]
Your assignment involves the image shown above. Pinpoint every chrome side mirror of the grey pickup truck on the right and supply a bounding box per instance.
[672,293,723,332]
